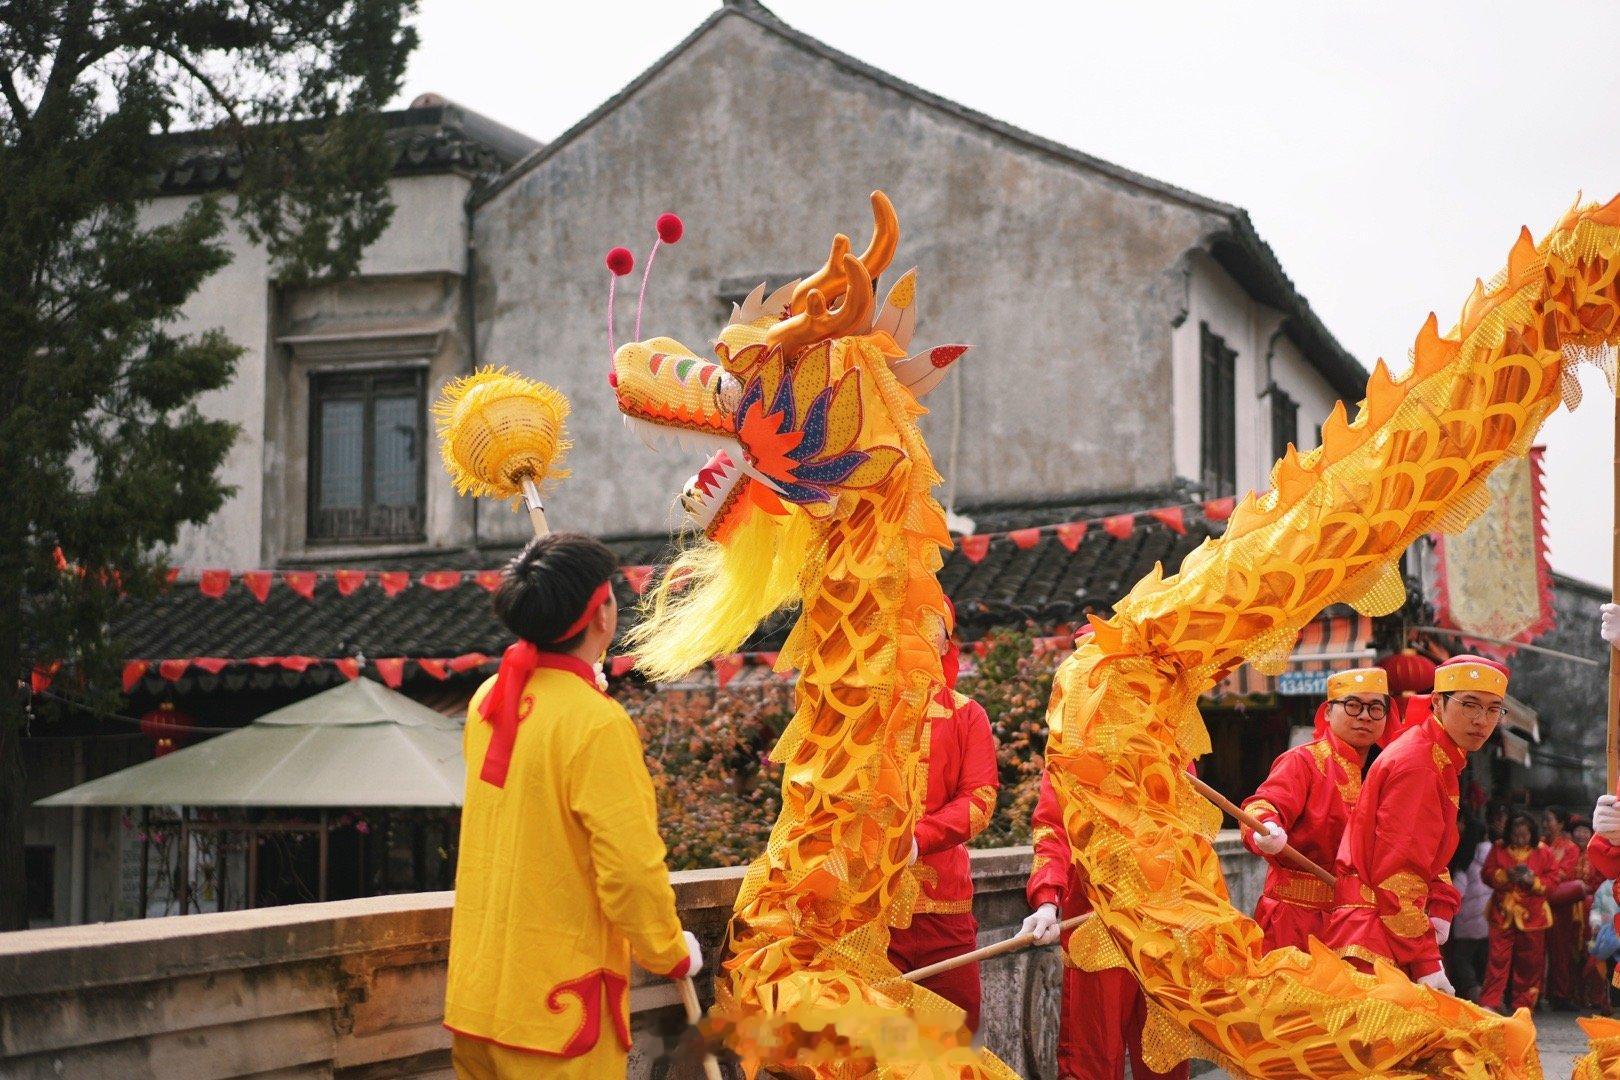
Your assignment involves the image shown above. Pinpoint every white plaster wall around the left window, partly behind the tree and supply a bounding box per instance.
[143,175,470,570]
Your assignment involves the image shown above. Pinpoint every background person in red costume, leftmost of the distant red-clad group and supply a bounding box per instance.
[1479,813,1558,1009]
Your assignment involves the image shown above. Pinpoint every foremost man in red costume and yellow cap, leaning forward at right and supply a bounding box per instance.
[1325,656,1508,994]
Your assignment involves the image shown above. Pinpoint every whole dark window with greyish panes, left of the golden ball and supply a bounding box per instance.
[309,371,426,542]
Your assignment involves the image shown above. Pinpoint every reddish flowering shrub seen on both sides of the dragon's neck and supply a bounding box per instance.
[614,631,1061,870]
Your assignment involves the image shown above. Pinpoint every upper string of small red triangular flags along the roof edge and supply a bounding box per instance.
[157,497,1236,604]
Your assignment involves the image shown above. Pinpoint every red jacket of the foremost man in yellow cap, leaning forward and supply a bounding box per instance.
[1327,717,1468,978]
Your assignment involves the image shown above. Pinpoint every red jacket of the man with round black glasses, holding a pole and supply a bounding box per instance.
[1243,732,1361,926]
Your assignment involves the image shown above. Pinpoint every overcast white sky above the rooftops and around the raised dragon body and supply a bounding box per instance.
[400,0,1620,585]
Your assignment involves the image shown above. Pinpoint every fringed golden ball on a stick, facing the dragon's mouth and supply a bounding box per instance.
[433,368,570,536]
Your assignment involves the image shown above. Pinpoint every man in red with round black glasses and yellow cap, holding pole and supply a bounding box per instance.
[1243,667,1390,952]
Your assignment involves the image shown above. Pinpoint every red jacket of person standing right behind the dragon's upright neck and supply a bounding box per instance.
[910,687,1001,915]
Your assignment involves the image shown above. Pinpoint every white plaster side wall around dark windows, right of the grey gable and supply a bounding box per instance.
[1171,254,1337,495]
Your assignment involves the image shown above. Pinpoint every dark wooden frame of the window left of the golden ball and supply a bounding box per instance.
[305,368,429,544]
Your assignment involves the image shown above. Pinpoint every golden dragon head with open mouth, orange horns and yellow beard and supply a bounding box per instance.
[611,191,966,667]
